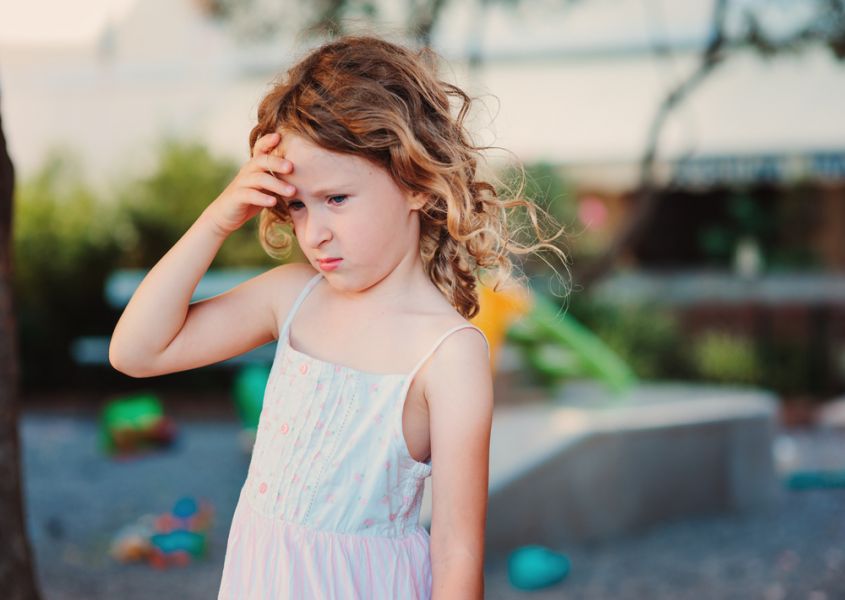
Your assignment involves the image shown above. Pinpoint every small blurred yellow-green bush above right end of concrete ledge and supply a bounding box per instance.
[689,330,763,385]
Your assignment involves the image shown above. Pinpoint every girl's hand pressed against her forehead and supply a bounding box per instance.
[204,133,296,236]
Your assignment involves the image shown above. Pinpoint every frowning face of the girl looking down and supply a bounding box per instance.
[276,133,421,292]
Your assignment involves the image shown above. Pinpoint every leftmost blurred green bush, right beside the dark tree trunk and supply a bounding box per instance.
[13,149,119,387]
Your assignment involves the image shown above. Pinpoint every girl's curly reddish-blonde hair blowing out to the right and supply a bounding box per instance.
[249,35,566,319]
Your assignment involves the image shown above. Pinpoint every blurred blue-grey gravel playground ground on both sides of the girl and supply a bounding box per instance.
[21,411,845,600]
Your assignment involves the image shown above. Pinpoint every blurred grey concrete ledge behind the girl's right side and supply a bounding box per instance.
[420,383,779,554]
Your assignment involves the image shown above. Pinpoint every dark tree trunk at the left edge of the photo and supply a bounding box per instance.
[0,91,41,600]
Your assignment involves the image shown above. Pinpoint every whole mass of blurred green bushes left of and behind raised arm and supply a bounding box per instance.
[13,140,284,389]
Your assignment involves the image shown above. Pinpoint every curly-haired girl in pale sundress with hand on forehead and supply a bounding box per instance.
[109,36,559,600]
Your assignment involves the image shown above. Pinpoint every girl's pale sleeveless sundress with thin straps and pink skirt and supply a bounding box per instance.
[218,273,489,600]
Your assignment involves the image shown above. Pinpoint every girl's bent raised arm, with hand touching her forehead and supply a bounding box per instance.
[109,133,301,377]
